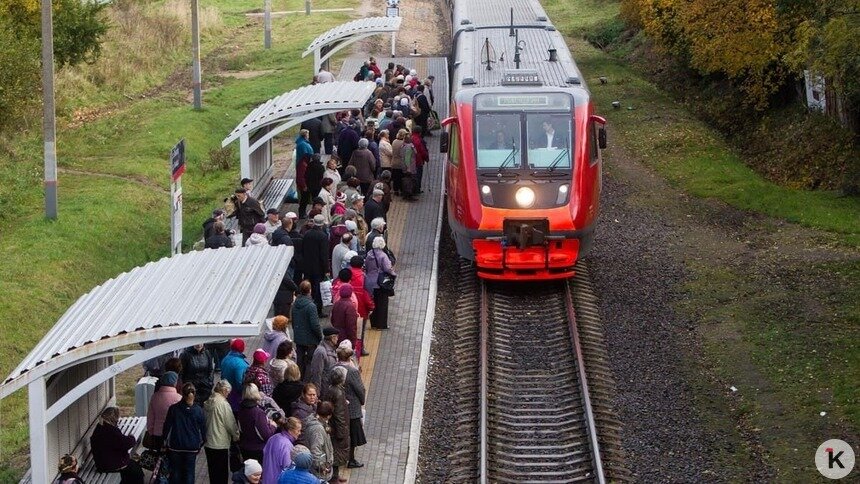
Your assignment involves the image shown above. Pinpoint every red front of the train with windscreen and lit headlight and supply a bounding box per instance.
[447,88,605,280]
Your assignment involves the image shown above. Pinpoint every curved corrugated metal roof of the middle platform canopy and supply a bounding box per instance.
[221,81,376,146]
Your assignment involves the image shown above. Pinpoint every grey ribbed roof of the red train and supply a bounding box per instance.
[453,0,585,89]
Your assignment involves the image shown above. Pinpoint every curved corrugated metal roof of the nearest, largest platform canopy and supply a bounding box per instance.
[0,246,293,397]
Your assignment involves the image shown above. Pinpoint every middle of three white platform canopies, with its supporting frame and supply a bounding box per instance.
[221,81,376,178]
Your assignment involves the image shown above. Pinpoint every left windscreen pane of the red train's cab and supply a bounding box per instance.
[474,113,522,169]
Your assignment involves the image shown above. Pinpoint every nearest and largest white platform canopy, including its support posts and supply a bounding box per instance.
[0,246,293,482]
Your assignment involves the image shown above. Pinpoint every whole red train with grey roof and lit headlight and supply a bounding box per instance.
[440,0,606,281]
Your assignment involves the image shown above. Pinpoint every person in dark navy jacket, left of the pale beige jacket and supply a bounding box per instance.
[163,383,206,484]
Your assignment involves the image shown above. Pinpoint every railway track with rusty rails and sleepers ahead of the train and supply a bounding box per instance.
[450,264,630,483]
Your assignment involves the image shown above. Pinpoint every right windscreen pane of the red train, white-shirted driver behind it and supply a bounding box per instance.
[526,113,573,169]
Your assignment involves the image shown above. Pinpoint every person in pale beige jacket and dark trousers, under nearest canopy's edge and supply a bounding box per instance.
[203,380,239,484]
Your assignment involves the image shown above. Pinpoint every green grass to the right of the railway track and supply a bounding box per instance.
[543,0,860,482]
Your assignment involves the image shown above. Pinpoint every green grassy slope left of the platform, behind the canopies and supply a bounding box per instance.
[0,0,355,476]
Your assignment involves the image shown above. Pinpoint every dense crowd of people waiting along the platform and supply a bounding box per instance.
[51,57,438,484]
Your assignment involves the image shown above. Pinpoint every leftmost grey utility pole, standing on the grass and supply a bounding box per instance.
[42,0,57,220]
